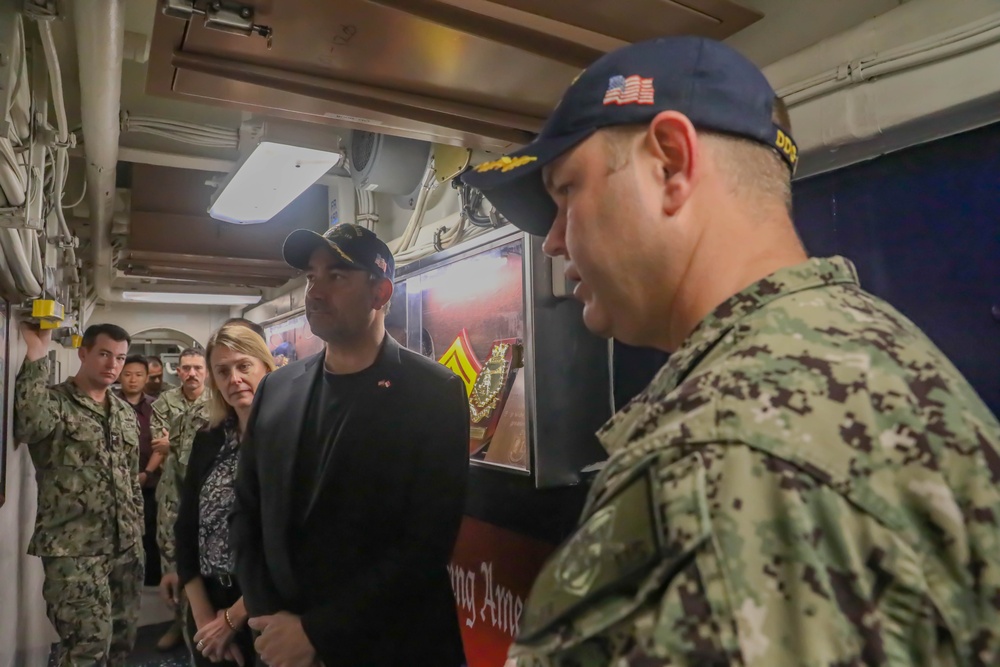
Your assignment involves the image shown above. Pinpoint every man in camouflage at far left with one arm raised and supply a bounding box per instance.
[14,324,144,667]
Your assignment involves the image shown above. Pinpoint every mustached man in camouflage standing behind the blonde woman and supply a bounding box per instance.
[150,348,209,650]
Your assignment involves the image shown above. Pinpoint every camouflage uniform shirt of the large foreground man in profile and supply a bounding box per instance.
[511,257,1000,667]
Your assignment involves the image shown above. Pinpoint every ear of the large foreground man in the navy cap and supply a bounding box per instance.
[645,111,702,216]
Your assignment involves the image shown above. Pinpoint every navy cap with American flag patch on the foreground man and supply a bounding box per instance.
[462,37,798,236]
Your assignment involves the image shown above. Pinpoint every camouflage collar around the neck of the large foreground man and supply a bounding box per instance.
[597,257,858,452]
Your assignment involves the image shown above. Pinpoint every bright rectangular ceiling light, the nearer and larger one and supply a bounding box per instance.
[208,141,343,224]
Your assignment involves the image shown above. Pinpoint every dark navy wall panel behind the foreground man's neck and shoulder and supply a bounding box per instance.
[794,118,1000,414]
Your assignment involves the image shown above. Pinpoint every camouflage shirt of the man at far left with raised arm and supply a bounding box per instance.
[14,359,143,557]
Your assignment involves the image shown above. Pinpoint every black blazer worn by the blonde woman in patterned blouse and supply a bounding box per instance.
[174,424,232,586]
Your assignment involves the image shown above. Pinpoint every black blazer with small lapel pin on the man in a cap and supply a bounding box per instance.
[230,335,469,667]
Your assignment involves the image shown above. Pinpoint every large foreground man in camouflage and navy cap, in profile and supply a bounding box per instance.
[463,38,1000,667]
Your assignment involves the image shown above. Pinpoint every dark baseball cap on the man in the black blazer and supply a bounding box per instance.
[281,222,396,280]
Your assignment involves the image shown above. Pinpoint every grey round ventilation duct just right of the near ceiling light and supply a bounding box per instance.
[351,130,431,196]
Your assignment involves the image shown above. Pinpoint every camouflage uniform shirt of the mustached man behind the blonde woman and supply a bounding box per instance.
[150,387,209,572]
